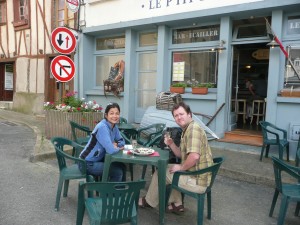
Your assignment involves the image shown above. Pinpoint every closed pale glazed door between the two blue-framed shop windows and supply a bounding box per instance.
[135,52,157,123]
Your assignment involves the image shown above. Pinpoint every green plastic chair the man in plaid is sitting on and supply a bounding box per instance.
[166,157,224,225]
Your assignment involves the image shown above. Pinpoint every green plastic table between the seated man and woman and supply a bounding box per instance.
[102,148,169,225]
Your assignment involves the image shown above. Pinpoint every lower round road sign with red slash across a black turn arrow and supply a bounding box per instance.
[50,55,75,82]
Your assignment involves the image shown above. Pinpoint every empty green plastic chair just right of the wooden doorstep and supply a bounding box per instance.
[259,121,289,161]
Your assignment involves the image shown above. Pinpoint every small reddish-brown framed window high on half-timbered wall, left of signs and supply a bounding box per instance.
[13,0,30,30]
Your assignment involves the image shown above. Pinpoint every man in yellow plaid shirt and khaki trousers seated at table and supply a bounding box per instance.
[139,102,213,214]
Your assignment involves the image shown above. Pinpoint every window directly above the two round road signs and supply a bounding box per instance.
[52,0,77,29]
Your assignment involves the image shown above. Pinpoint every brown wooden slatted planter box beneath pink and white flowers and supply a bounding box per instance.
[45,110,103,140]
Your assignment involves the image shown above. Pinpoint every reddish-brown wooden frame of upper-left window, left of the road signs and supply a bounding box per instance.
[12,0,30,30]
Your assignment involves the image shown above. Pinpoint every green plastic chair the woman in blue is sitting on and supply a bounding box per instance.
[51,137,86,211]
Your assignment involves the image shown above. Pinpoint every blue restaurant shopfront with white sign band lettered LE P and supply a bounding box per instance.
[74,0,300,158]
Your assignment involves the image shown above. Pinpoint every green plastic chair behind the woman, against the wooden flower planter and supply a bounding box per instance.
[69,120,92,145]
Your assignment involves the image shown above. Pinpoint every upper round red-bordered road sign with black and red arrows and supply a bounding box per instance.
[51,27,76,54]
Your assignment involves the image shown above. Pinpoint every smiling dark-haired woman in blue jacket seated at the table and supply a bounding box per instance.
[79,103,126,182]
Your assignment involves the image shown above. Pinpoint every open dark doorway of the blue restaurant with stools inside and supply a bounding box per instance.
[230,43,269,132]
